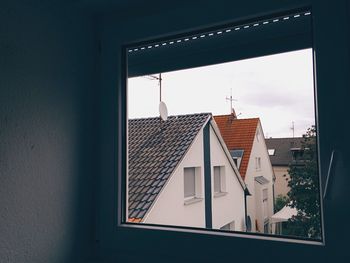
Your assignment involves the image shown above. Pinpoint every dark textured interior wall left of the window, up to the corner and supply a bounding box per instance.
[0,1,96,263]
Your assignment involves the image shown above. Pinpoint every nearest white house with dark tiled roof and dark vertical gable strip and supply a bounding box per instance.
[127,113,246,231]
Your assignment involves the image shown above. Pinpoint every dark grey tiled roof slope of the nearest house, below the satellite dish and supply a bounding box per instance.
[128,113,211,222]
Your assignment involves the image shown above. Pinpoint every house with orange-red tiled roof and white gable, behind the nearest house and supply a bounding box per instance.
[214,114,274,233]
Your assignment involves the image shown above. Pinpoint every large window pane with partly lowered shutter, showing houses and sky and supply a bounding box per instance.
[125,9,322,240]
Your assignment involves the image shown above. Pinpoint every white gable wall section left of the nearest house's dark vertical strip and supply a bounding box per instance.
[143,130,205,227]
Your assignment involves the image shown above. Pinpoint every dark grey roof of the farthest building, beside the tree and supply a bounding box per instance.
[265,137,303,166]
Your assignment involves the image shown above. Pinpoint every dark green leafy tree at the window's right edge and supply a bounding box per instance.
[288,126,321,239]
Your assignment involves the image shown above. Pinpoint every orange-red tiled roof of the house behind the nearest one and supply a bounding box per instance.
[214,114,259,180]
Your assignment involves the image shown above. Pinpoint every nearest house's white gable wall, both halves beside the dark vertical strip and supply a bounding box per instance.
[143,122,245,231]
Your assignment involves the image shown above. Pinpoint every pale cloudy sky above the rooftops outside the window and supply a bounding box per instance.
[128,49,315,138]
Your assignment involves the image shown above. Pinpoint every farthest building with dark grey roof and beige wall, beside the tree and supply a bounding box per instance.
[265,137,303,198]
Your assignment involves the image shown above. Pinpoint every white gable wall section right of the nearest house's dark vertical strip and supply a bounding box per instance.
[210,128,245,231]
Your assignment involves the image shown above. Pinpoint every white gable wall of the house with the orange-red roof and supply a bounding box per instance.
[245,122,273,232]
